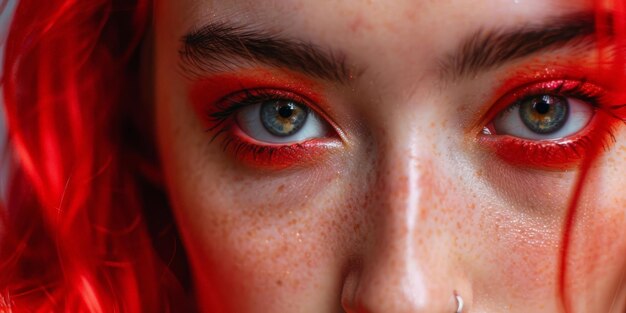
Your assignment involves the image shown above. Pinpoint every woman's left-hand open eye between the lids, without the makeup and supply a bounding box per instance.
[236,98,329,144]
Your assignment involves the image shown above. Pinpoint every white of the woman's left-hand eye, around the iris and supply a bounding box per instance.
[236,102,329,144]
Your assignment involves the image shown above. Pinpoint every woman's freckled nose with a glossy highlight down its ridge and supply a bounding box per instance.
[342,140,471,313]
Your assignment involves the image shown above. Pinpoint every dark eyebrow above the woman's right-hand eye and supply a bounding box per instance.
[439,12,600,80]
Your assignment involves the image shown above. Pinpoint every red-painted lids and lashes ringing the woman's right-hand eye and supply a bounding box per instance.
[479,79,615,170]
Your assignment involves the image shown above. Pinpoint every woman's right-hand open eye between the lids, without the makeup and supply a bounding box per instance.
[493,94,594,140]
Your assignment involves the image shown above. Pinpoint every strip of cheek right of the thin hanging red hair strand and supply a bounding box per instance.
[567,160,626,312]
